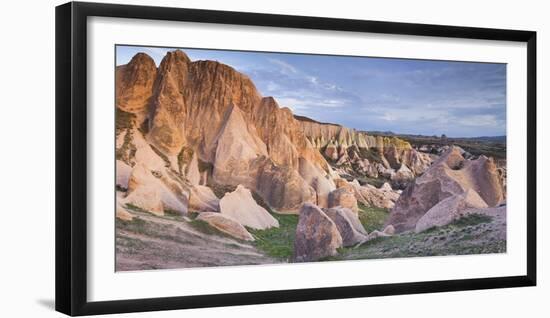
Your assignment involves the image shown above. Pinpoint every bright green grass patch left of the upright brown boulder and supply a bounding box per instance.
[247,213,298,261]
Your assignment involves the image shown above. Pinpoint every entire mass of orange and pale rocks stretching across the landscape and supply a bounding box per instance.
[116,50,505,261]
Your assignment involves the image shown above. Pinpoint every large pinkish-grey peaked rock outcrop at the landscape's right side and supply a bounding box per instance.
[387,147,504,232]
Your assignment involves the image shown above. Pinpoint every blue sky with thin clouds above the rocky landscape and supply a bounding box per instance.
[116,46,506,137]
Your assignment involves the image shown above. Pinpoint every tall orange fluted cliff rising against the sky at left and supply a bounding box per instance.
[116,50,333,212]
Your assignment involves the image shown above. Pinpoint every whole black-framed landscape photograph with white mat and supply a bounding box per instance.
[56,2,536,315]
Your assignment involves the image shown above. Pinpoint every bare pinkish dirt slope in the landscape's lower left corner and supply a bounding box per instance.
[116,211,278,271]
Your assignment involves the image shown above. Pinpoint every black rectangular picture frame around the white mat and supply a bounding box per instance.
[55,2,536,315]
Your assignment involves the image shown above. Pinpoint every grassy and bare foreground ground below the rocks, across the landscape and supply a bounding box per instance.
[116,206,506,271]
